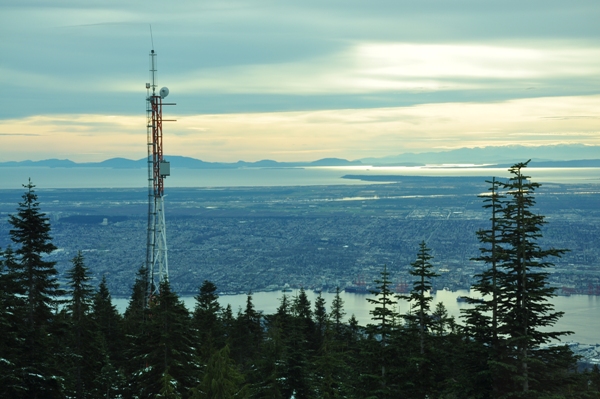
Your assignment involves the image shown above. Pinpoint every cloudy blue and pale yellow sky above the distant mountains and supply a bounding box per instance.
[0,0,600,162]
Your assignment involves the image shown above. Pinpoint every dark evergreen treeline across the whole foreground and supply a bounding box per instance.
[0,163,600,399]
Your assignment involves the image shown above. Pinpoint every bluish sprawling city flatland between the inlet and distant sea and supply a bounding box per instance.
[0,183,600,295]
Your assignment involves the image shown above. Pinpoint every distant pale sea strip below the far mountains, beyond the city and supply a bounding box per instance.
[0,166,600,192]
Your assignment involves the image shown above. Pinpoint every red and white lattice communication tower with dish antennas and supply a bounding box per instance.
[146,50,176,295]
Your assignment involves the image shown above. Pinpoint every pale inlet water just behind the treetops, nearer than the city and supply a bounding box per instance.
[113,290,600,344]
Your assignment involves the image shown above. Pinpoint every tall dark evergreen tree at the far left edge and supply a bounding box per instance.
[9,180,64,399]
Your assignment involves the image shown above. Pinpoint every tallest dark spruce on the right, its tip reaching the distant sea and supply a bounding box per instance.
[498,161,569,397]
